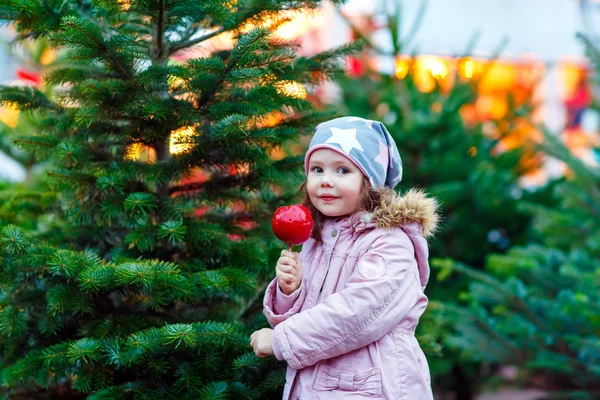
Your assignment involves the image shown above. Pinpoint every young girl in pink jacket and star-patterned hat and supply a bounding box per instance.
[250,117,438,400]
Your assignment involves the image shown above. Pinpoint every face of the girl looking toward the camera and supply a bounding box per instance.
[306,149,364,217]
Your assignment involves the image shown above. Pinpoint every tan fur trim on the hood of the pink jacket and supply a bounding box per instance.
[372,189,440,238]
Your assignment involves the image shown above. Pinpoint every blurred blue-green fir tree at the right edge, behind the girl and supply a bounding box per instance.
[435,33,600,399]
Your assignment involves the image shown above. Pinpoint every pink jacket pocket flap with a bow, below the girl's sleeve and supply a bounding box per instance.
[313,364,382,397]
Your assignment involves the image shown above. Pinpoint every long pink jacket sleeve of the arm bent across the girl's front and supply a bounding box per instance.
[273,233,424,369]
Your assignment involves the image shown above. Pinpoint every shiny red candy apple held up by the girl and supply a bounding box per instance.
[271,204,313,247]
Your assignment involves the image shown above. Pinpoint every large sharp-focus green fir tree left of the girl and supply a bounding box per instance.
[0,0,351,399]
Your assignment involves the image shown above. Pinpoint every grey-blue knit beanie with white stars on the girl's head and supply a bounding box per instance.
[304,117,402,189]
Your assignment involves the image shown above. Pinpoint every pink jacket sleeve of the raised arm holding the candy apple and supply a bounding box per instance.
[263,279,306,327]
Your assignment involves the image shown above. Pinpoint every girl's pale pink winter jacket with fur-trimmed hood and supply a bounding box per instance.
[264,190,438,400]
